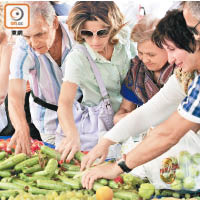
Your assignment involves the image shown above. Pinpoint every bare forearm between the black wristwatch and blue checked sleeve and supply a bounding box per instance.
[126,112,199,169]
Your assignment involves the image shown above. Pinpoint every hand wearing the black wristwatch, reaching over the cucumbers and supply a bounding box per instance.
[81,163,123,189]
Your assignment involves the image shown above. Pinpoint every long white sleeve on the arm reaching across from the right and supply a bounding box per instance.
[104,75,186,142]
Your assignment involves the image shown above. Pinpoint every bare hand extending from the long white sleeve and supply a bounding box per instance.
[81,138,110,171]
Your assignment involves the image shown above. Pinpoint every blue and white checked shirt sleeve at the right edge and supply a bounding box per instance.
[178,74,200,123]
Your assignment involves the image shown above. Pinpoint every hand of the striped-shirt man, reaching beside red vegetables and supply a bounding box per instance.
[7,126,31,155]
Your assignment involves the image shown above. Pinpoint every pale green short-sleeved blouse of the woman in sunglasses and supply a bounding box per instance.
[63,27,136,112]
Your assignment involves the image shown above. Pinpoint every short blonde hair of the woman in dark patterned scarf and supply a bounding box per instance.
[131,15,159,42]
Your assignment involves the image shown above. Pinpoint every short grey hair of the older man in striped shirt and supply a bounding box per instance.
[25,1,56,26]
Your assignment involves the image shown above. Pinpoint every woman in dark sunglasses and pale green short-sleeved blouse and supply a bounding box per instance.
[57,1,135,160]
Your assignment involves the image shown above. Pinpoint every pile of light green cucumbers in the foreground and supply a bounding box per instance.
[0,146,141,200]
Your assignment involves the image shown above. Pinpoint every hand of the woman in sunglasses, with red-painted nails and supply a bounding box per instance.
[57,137,80,162]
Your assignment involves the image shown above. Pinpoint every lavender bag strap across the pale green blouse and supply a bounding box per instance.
[75,44,109,98]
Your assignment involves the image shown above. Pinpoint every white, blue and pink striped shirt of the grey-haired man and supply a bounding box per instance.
[10,20,72,135]
